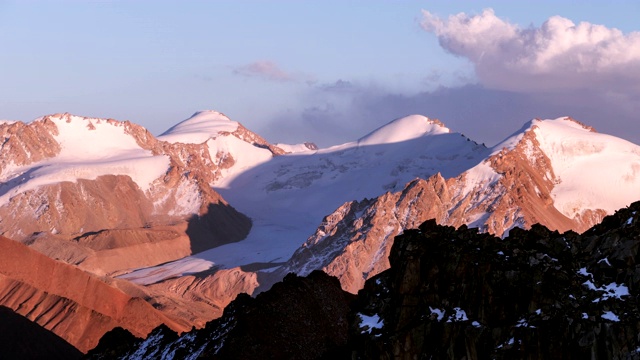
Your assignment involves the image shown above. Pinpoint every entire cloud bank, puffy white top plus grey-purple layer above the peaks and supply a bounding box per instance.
[263,10,640,146]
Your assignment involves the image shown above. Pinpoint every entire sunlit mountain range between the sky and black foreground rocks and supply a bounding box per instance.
[0,111,640,352]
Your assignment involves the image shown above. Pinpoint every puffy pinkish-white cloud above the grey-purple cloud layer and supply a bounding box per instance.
[422,9,640,93]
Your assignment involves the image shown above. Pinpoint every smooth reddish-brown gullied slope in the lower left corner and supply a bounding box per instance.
[0,237,188,352]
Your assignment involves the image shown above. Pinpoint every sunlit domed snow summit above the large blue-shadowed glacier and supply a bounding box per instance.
[358,115,450,145]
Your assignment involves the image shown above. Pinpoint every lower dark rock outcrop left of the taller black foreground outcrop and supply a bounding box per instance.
[87,272,353,359]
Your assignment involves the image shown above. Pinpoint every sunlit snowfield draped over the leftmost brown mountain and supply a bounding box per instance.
[0,115,169,206]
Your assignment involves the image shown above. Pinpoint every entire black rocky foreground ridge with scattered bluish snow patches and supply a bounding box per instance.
[87,203,640,359]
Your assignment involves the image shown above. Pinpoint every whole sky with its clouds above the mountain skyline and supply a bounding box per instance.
[0,0,640,146]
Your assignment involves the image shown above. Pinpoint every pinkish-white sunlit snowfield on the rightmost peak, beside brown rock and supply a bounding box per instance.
[531,118,640,218]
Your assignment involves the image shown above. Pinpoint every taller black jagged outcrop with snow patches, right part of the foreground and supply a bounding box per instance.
[356,203,640,359]
